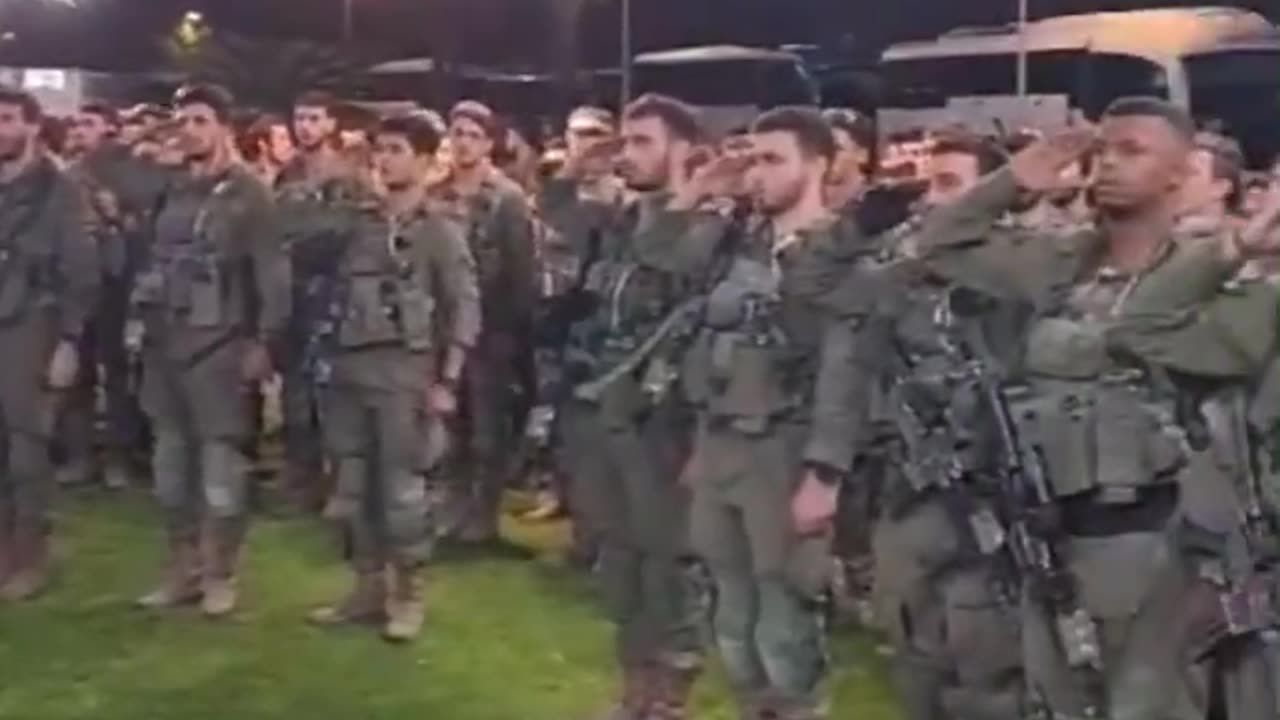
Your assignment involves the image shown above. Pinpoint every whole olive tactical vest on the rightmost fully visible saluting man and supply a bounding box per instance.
[1005,318,1187,503]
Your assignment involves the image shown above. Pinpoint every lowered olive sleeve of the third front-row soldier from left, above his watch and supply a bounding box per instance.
[422,213,481,348]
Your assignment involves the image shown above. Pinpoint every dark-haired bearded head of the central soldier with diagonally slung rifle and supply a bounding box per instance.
[620,95,704,191]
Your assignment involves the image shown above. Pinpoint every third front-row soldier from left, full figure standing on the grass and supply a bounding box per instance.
[304,118,480,641]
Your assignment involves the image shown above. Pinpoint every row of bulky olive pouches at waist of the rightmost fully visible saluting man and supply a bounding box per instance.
[1006,373,1187,505]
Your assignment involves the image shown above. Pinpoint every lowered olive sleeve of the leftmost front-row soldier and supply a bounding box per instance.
[49,177,100,337]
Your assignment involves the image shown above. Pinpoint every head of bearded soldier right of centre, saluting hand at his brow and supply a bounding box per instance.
[746,108,836,215]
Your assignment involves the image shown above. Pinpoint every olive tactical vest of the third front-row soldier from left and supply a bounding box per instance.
[337,210,435,352]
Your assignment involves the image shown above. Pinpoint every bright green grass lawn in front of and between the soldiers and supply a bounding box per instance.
[0,492,897,720]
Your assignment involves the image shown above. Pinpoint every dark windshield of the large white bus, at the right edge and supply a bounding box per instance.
[1184,47,1280,168]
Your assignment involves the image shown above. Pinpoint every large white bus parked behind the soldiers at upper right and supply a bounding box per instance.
[881,6,1280,167]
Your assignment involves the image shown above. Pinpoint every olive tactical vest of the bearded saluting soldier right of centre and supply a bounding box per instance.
[685,256,805,434]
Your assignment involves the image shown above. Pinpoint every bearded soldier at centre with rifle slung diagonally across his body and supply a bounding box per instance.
[562,96,724,720]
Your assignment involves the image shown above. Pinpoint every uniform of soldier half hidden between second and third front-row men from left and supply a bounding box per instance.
[275,159,361,505]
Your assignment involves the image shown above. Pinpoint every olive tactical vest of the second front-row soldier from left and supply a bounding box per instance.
[132,178,234,329]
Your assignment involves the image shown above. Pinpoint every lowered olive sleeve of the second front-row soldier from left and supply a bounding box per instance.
[242,181,292,337]
